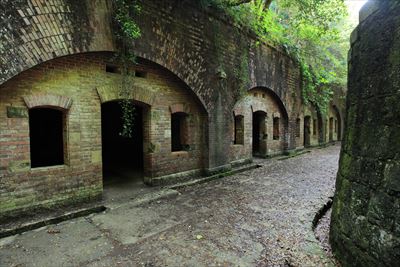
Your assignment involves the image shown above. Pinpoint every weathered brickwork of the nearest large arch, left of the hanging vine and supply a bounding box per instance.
[0,0,115,85]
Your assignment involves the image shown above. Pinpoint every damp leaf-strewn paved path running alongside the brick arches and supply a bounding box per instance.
[0,146,339,267]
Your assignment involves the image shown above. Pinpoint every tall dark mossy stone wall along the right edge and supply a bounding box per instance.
[330,1,400,266]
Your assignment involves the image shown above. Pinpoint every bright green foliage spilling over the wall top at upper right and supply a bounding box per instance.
[201,0,351,113]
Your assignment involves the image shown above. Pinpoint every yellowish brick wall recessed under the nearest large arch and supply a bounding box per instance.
[0,53,207,220]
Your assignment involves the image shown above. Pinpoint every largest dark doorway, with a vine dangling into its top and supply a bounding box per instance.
[101,101,144,186]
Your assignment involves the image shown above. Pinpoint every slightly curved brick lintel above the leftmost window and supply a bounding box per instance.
[23,94,72,110]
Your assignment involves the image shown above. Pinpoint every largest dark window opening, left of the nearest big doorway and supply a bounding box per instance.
[29,108,64,168]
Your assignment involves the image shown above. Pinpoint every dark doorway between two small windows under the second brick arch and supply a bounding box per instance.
[253,111,267,156]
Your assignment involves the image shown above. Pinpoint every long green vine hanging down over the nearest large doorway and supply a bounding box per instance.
[113,0,141,138]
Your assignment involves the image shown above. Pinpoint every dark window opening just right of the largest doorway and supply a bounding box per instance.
[171,112,189,152]
